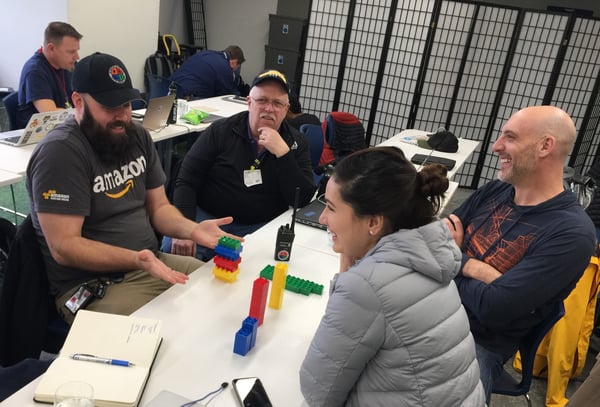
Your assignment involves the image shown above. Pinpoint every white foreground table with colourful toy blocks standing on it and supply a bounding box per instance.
[2,211,338,407]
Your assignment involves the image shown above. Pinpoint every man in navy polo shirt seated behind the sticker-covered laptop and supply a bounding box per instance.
[17,21,83,128]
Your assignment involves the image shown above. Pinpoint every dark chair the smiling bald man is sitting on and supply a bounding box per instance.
[492,301,565,407]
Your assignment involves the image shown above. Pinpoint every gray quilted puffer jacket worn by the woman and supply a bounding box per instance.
[300,221,485,407]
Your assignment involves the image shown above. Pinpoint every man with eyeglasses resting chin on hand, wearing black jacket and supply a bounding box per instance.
[162,70,315,261]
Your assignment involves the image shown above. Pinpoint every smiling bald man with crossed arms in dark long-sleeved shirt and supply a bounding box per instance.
[446,106,596,405]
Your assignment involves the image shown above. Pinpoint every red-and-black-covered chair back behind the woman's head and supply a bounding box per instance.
[320,112,367,165]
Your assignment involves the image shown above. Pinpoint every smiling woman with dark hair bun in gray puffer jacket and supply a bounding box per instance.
[300,147,485,407]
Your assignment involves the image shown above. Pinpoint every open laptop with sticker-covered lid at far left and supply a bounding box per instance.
[0,109,74,147]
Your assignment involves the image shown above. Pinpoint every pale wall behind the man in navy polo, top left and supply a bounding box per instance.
[0,0,160,89]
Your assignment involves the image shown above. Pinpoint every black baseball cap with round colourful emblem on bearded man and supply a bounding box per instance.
[73,52,143,108]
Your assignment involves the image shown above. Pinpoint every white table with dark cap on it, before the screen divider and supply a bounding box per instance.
[379,129,479,179]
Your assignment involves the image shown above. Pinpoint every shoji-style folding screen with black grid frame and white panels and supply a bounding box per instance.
[300,0,600,188]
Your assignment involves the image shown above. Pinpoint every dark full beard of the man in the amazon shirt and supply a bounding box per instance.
[79,106,136,164]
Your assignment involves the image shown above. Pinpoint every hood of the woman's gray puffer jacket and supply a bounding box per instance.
[361,220,462,283]
